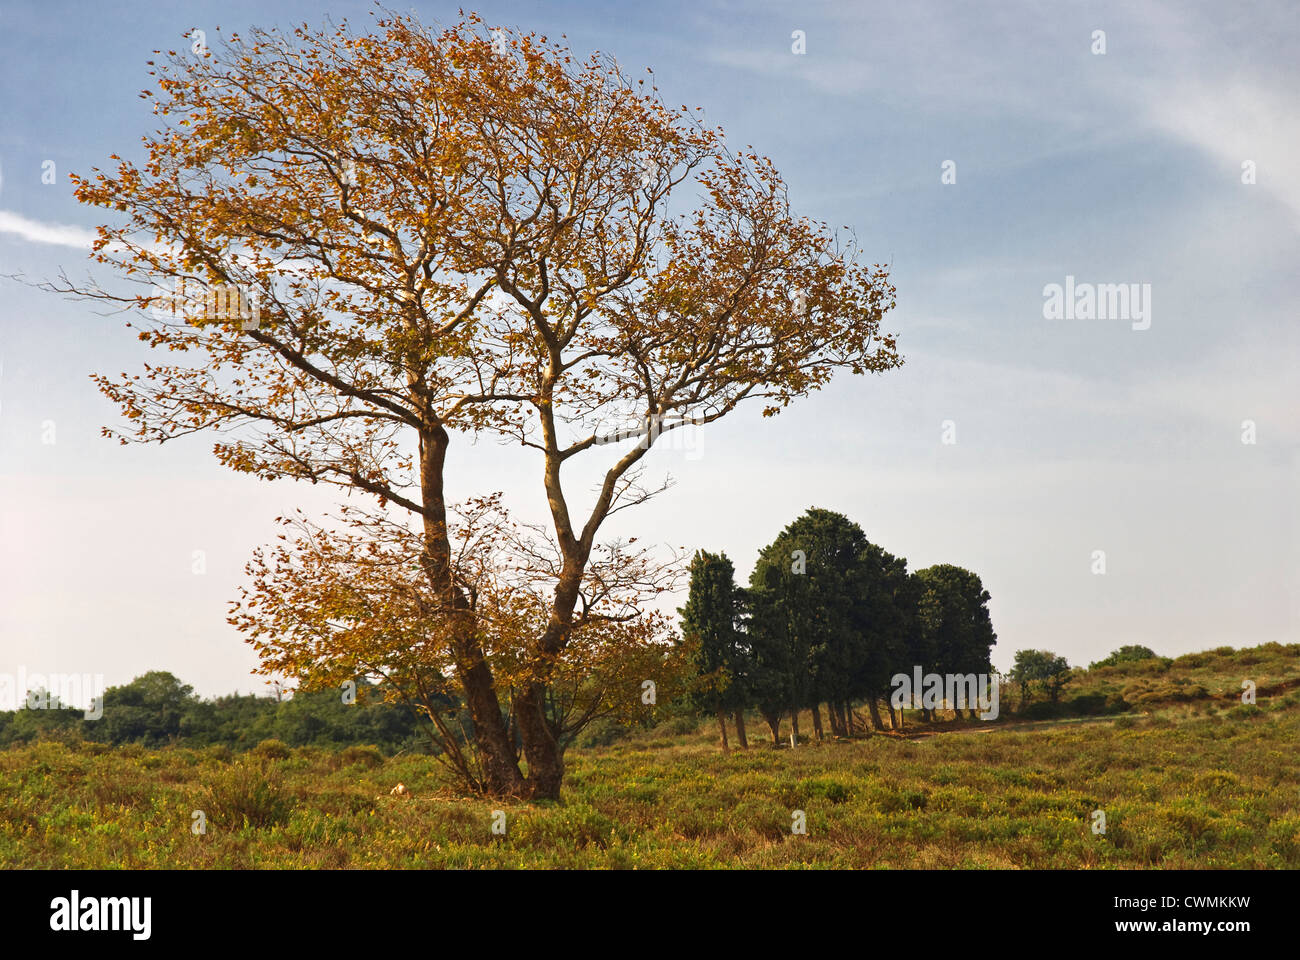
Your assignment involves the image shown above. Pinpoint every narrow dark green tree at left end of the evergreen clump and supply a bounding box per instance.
[677,550,750,751]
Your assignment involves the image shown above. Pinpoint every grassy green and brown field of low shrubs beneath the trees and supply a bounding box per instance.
[0,648,1300,869]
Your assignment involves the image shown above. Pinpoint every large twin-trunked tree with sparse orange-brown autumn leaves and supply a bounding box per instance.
[47,14,902,797]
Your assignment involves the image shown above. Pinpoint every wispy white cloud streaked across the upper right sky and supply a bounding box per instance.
[710,0,1300,226]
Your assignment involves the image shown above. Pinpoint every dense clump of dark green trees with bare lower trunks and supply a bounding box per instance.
[679,507,997,749]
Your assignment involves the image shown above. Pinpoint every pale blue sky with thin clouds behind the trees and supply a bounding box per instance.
[0,0,1300,696]
